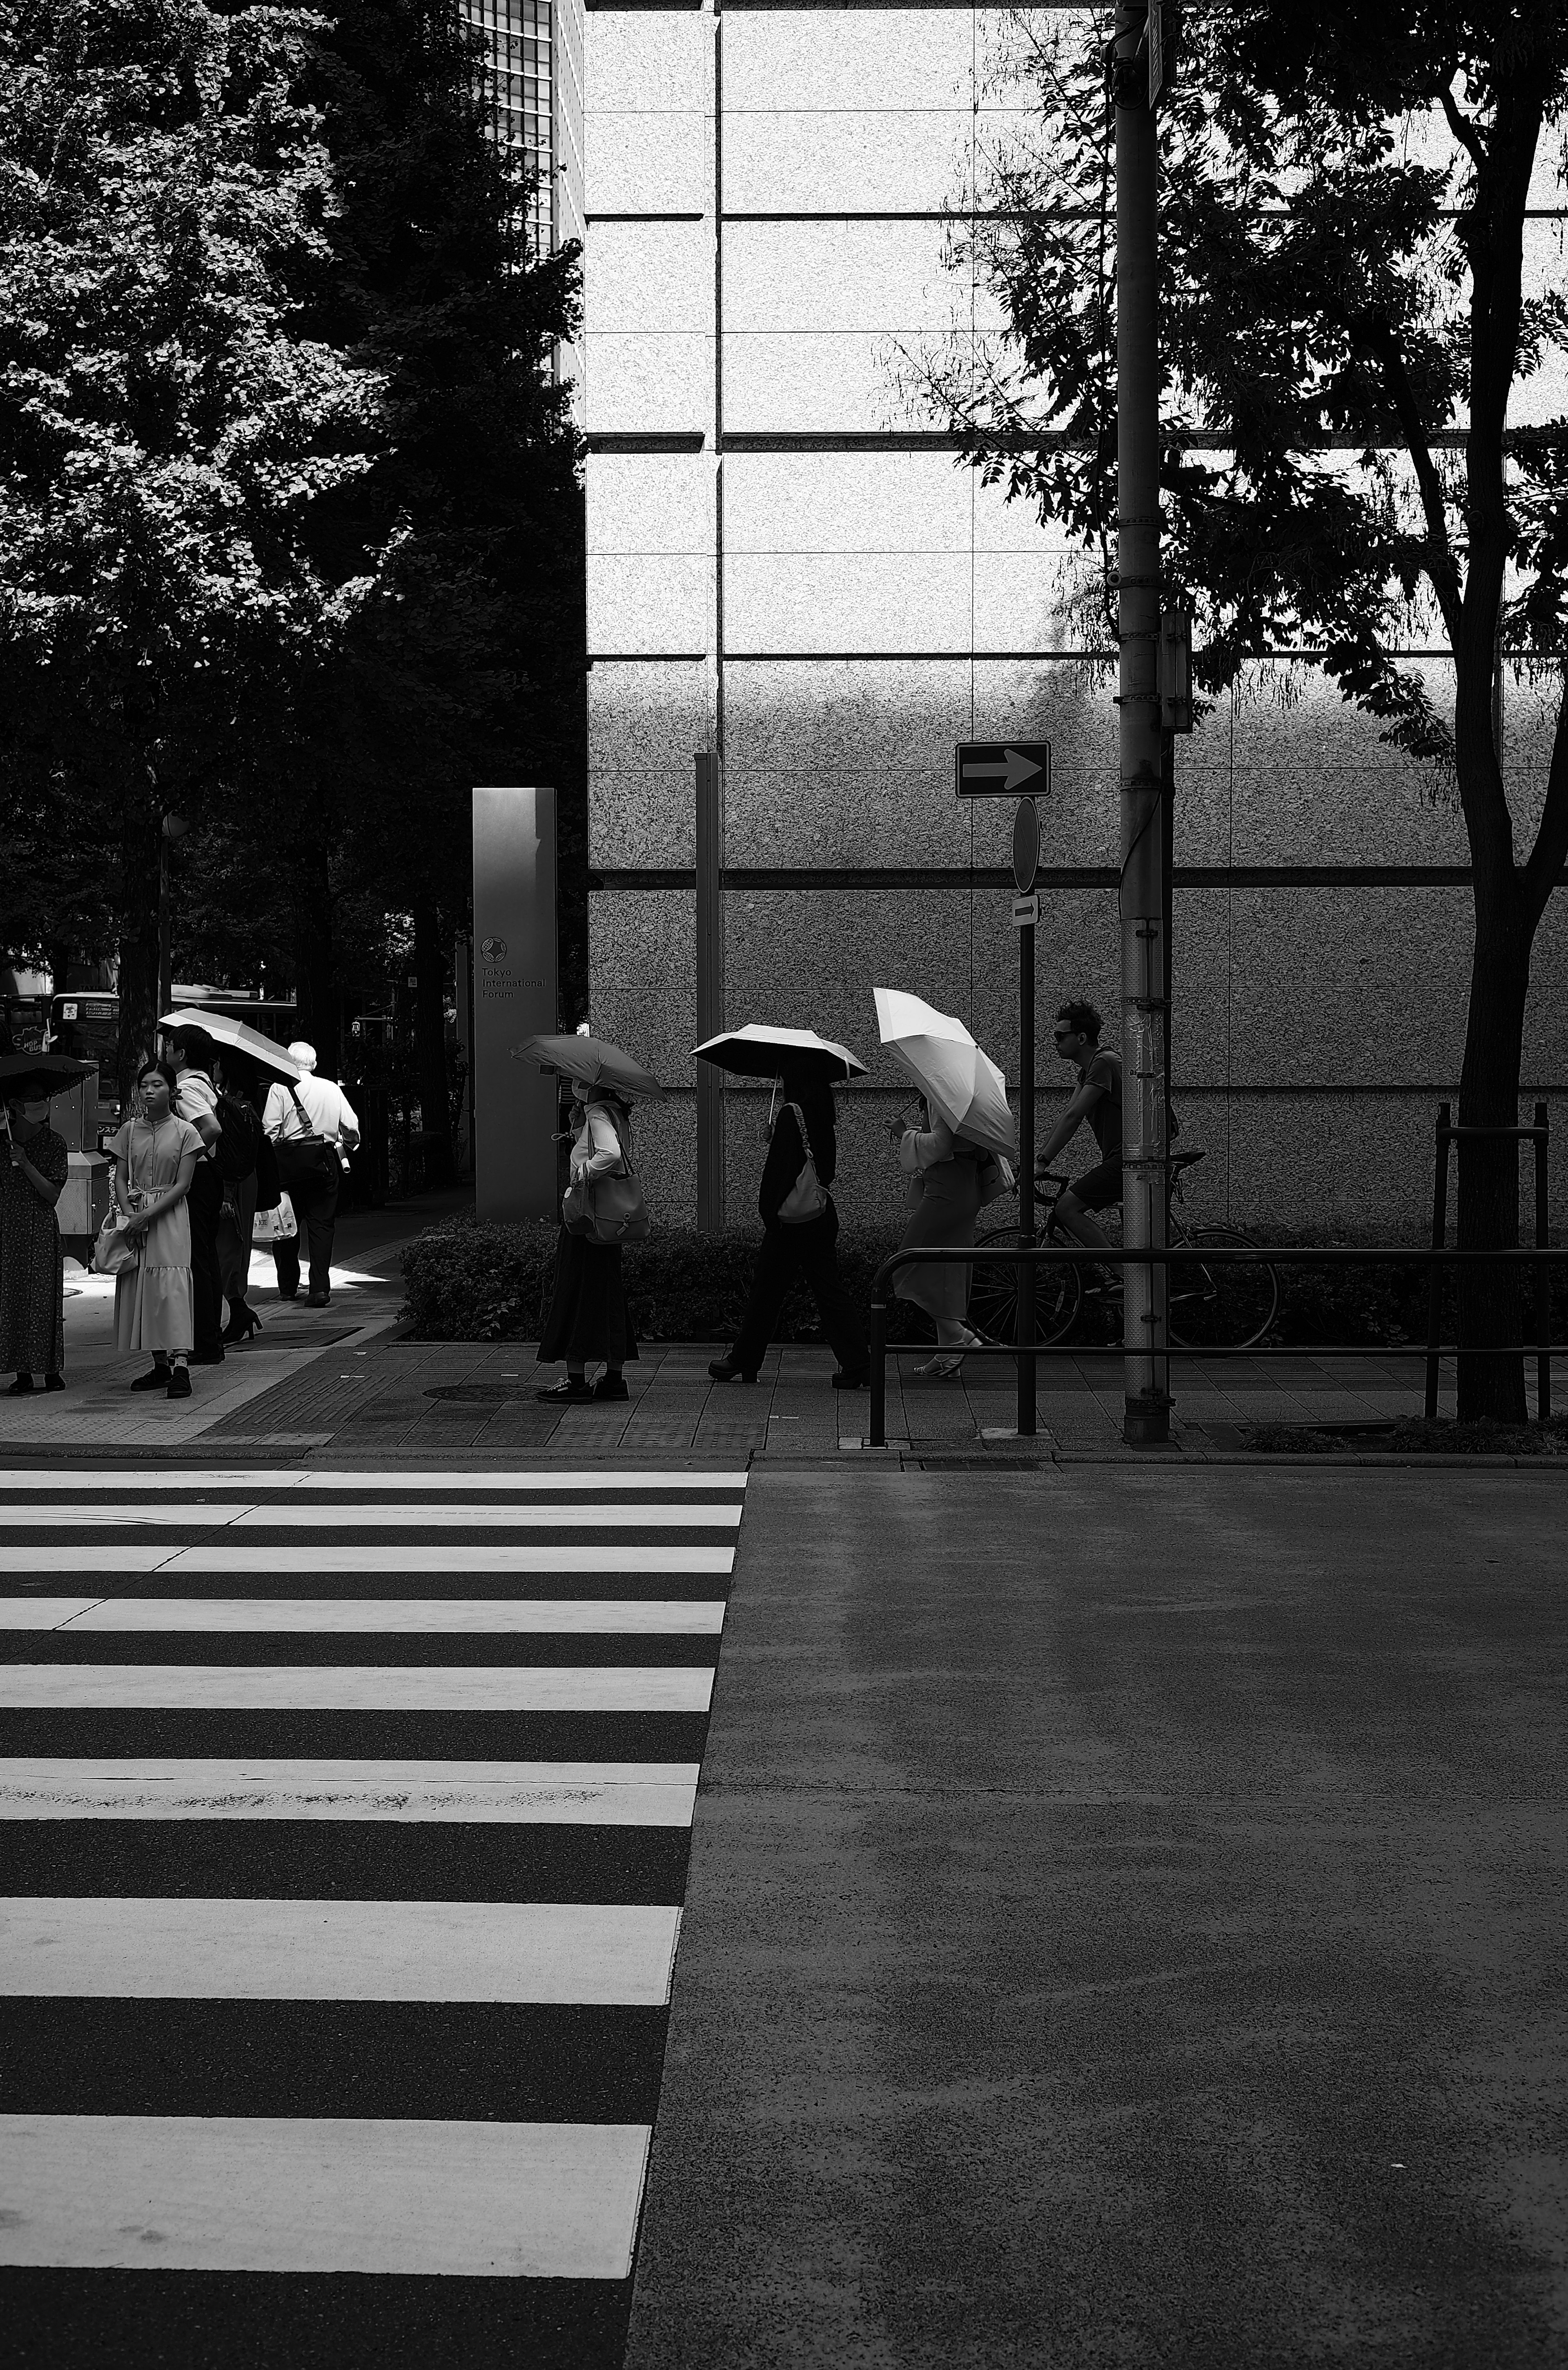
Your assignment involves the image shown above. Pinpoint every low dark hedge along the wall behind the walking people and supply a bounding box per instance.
[403,1216,1568,1348]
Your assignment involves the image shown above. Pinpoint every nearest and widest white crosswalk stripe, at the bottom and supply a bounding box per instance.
[0,2114,649,2280]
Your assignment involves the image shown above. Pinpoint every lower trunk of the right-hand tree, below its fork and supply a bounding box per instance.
[1457,889,1535,1424]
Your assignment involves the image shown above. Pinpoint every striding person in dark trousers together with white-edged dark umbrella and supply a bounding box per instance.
[696,1024,872,1391]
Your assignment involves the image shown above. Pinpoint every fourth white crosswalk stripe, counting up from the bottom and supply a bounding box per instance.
[0,1662,713,1711]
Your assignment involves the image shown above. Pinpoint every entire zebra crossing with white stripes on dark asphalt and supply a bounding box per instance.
[0,1467,746,2370]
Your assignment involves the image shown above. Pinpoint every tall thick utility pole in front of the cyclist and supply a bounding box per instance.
[1113,5,1170,1446]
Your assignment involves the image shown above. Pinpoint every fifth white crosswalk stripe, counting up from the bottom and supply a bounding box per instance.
[0,1597,725,1638]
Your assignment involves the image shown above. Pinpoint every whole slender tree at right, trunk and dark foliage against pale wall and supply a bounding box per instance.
[933,0,1568,1420]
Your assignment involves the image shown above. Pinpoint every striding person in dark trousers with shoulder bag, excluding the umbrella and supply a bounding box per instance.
[708,1064,872,1391]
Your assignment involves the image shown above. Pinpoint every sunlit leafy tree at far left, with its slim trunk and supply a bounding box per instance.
[0,0,379,1100]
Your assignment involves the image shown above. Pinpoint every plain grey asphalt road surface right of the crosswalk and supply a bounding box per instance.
[628,1467,1568,2370]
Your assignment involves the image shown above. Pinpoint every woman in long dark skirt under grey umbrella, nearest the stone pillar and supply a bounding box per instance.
[512,1036,663,1406]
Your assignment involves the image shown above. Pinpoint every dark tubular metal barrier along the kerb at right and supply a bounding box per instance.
[869,1242,1568,1448]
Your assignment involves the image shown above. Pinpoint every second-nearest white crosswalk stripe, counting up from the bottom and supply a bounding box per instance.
[0,1893,680,2007]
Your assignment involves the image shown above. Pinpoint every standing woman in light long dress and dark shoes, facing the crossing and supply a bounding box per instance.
[104,1062,201,1398]
